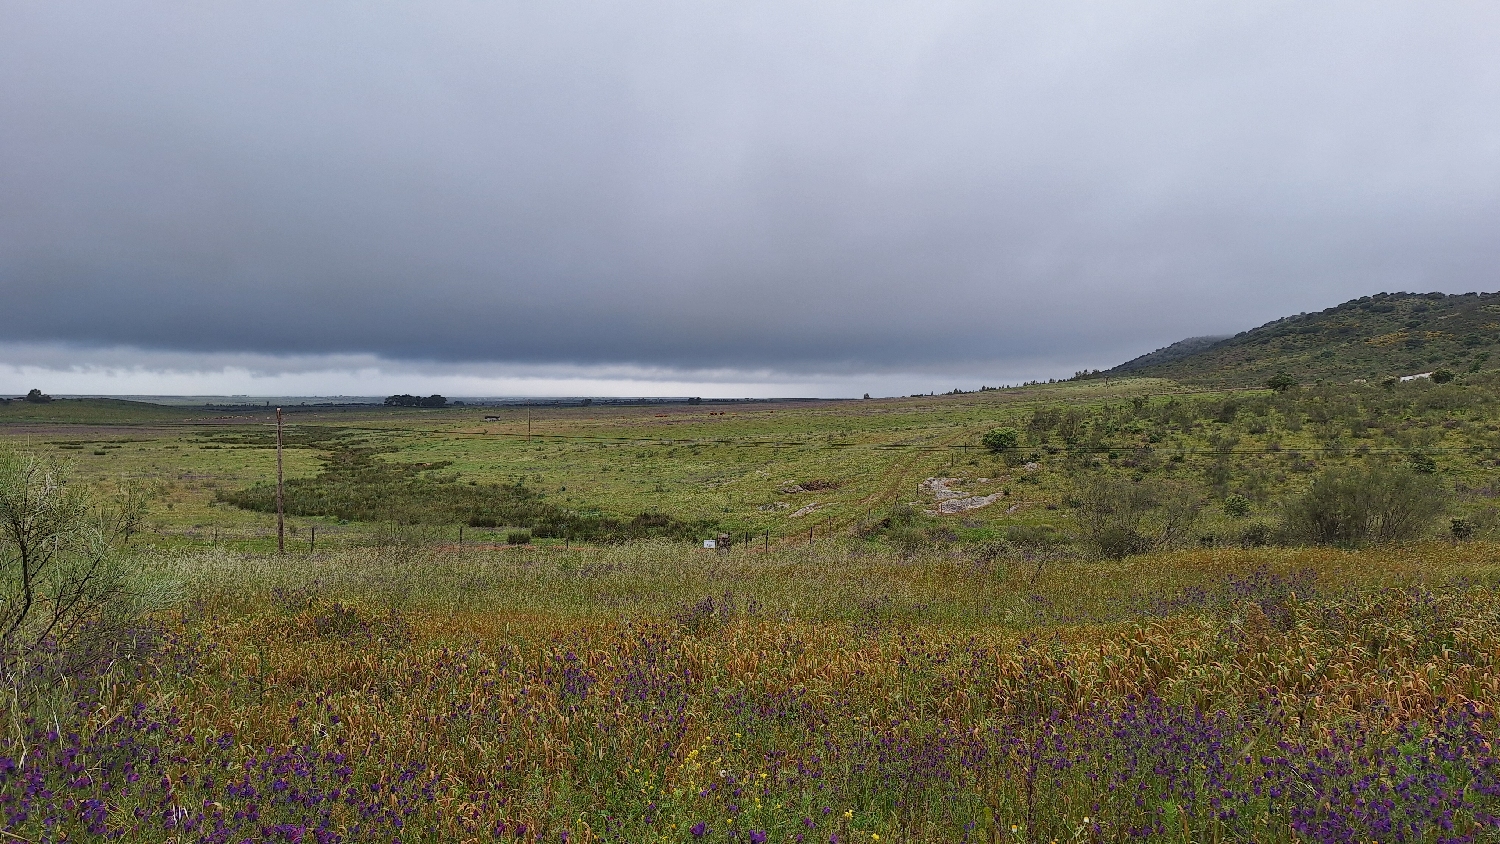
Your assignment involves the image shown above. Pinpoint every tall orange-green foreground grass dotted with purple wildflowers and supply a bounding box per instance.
[0,544,1500,843]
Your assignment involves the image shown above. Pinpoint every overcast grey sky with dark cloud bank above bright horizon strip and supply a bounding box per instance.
[0,0,1500,397]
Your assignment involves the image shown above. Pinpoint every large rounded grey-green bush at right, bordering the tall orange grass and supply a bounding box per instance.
[1287,465,1446,546]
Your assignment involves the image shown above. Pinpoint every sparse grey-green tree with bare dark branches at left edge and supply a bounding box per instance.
[0,453,146,682]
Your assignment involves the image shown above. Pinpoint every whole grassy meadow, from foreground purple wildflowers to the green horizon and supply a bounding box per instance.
[0,381,1500,844]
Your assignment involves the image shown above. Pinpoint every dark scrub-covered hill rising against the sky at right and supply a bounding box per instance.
[1092,292,1500,387]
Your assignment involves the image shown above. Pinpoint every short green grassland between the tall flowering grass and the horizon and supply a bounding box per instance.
[11,375,1500,547]
